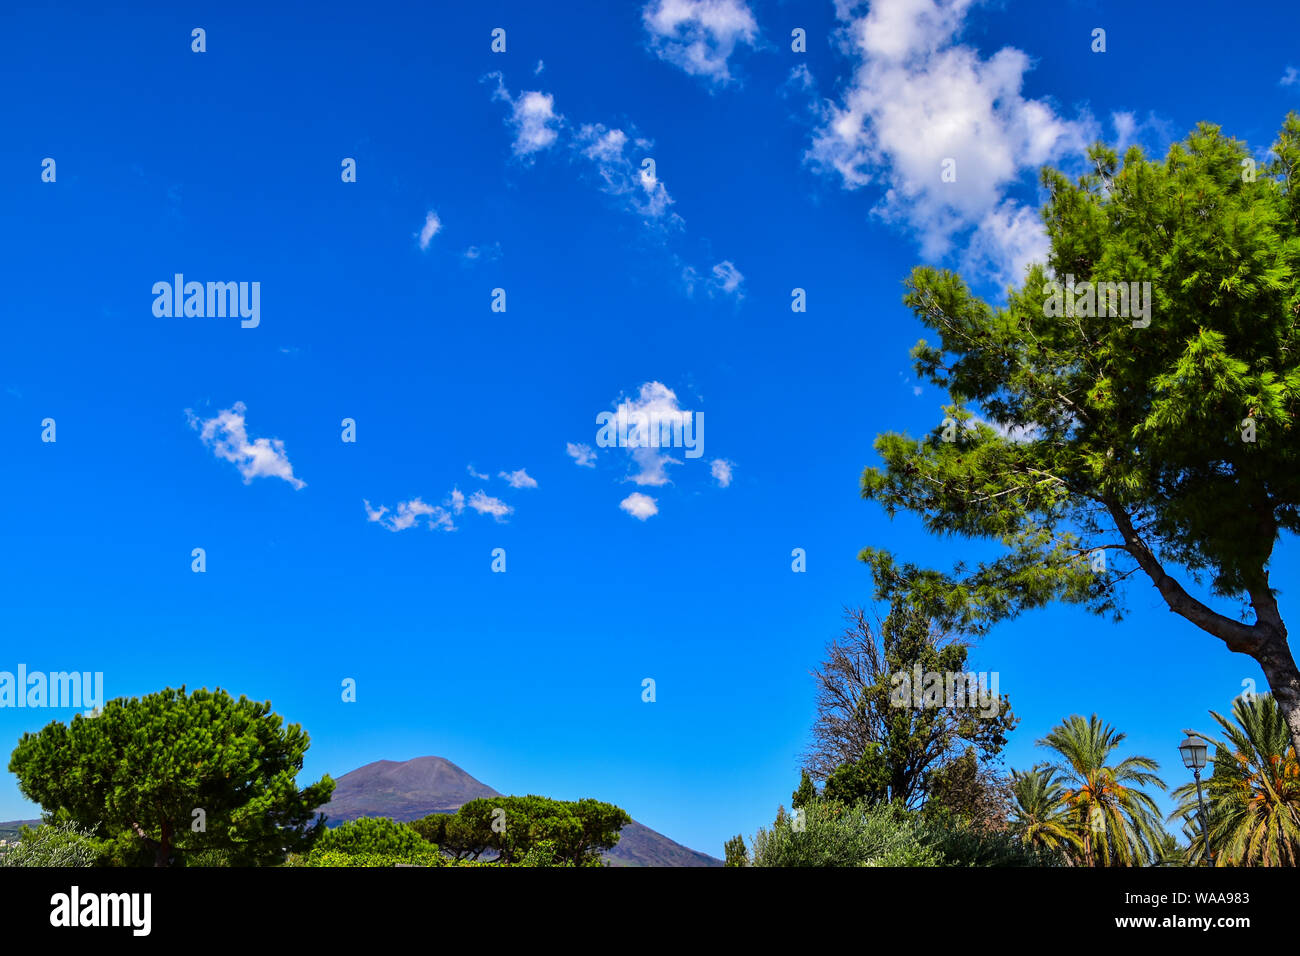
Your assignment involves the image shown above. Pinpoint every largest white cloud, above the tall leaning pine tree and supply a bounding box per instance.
[806,0,1095,281]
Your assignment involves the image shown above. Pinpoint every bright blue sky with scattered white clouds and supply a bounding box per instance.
[0,0,1300,856]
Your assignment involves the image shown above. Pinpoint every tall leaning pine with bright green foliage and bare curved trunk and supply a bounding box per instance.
[861,113,1300,747]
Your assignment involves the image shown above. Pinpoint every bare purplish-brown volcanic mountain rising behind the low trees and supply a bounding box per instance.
[321,757,723,866]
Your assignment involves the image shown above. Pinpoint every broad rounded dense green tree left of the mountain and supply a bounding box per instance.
[9,687,334,866]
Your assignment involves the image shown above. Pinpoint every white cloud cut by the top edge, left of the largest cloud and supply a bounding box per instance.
[641,0,758,86]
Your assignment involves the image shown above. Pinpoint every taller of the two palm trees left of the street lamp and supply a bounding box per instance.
[1037,714,1165,866]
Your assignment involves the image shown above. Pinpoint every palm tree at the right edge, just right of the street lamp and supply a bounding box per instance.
[1170,693,1300,866]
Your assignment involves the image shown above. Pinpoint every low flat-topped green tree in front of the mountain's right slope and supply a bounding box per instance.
[411,795,632,866]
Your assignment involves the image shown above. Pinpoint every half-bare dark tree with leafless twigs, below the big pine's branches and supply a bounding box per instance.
[809,602,1018,808]
